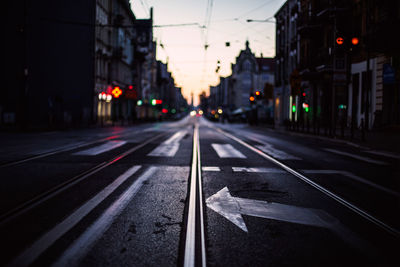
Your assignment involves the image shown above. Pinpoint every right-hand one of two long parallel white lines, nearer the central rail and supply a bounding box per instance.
[53,166,158,267]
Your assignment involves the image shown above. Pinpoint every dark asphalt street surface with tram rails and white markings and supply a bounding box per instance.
[0,116,400,266]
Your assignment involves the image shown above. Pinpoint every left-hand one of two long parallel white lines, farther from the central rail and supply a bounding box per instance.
[9,166,141,266]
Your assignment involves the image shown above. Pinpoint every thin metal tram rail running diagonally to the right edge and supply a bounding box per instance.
[214,128,400,237]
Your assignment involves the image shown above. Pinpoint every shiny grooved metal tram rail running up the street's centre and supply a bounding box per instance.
[183,123,206,267]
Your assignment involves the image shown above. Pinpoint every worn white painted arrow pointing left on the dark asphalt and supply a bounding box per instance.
[206,187,339,232]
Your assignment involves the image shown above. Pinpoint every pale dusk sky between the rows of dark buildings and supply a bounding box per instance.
[131,0,285,105]
